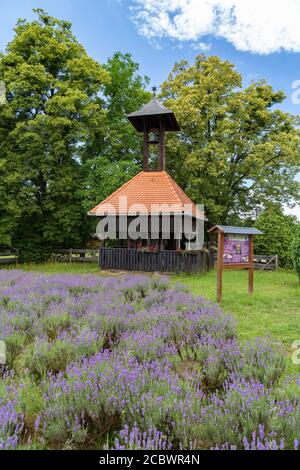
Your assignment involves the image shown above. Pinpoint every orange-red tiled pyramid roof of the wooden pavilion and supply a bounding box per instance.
[90,171,203,217]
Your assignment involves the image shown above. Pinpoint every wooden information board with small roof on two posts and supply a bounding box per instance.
[208,225,262,303]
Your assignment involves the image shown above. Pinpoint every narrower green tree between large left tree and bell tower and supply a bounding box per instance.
[81,52,151,210]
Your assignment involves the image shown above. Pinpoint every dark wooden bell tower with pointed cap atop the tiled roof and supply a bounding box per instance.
[127,87,180,171]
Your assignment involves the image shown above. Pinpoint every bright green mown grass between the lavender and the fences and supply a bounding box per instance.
[2,263,300,372]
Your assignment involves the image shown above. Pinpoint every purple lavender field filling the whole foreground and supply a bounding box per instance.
[0,270,300,449]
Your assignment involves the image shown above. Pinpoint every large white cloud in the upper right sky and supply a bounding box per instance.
[132,0,300,54]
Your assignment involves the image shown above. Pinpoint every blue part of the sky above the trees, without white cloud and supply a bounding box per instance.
[0,0,300,114]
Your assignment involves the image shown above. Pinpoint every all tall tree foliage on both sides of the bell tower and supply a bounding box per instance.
[0,9,299,253]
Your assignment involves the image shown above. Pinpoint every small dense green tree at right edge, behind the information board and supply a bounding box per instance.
[255,205,297,268]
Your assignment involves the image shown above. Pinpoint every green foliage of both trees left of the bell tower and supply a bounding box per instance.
[0,9,149,261]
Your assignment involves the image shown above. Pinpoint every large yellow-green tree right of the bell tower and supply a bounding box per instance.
[161,55,300,224]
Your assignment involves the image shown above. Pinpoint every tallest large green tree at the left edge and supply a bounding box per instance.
[0,9,110,258]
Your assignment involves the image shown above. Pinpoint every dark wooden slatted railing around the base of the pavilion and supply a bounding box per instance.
[99,248,214,272]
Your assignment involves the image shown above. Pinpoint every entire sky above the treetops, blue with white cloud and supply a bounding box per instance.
[0,0,300,218]
